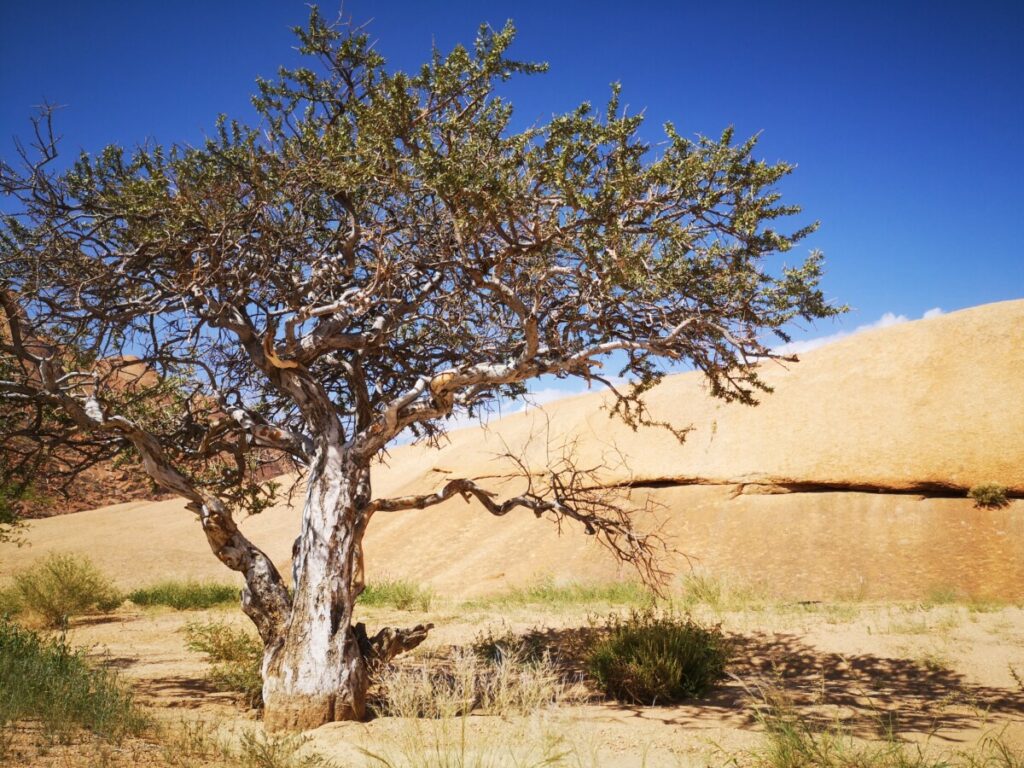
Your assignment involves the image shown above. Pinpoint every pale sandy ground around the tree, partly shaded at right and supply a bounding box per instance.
[12,602,1024,768]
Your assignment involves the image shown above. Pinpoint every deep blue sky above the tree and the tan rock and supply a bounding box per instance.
[0,0,1024,336]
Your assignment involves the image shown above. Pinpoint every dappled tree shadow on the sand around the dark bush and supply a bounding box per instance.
[462,627,1024,740]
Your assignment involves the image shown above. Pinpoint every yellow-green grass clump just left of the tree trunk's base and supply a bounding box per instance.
[184,622,263,707]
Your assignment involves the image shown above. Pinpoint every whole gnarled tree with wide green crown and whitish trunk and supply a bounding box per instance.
[0,10,837,727]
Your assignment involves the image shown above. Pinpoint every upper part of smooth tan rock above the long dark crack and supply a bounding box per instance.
[396,301,1024,496]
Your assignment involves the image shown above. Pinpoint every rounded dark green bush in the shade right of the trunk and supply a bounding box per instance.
[587,609,730,705]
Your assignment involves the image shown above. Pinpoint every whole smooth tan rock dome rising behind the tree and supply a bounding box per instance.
[0,301,1024,599]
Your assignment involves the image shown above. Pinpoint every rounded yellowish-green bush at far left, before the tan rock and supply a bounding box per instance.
[13,554,124,627]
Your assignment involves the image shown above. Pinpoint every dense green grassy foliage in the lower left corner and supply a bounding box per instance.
[0,618,147,742]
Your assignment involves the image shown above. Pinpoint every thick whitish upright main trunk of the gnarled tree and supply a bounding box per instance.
[263,447,370,730]
